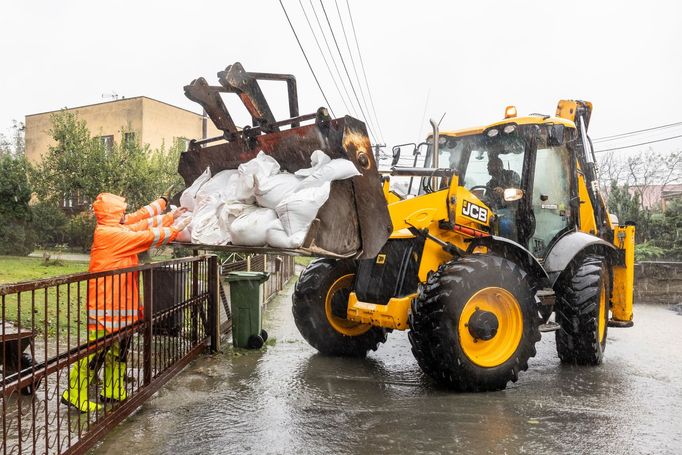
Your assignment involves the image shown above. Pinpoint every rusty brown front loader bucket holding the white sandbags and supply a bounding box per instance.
[178,114,392,259]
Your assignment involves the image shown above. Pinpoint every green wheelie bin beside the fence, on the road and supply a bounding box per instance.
[225,272,270,349]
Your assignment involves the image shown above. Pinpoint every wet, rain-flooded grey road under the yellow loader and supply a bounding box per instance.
[94,289,682,455]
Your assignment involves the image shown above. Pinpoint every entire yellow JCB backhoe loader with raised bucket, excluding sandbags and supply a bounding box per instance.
[180,64,634,391]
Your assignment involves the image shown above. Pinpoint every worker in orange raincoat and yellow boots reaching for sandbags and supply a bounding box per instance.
[62,193,190,412]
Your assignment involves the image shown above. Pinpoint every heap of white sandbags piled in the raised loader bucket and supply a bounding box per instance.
[177,150,360,248]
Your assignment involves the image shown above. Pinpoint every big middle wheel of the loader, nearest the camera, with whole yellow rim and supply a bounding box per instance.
[409,254,540,392]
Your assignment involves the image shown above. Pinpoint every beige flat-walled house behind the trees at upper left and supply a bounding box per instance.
[25,96,221,162]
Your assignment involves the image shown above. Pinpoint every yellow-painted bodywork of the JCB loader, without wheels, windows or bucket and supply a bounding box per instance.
[347,100,635,330]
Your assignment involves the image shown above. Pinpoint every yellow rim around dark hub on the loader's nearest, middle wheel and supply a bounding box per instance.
[458,287,523,368]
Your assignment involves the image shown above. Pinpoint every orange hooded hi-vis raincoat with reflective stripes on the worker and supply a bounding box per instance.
[88,193,179,332]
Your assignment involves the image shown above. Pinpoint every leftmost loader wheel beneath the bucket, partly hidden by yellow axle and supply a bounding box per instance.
[292,259,386,357]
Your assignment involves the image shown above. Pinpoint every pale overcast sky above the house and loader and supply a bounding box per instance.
[0,0,682,156]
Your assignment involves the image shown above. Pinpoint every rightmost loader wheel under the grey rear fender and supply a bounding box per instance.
[555,255,611,365]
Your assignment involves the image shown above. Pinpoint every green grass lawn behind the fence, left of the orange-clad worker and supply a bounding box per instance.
[0,256,88,336]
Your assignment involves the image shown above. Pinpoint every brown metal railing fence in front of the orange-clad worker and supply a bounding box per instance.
[0,256,220,455]
